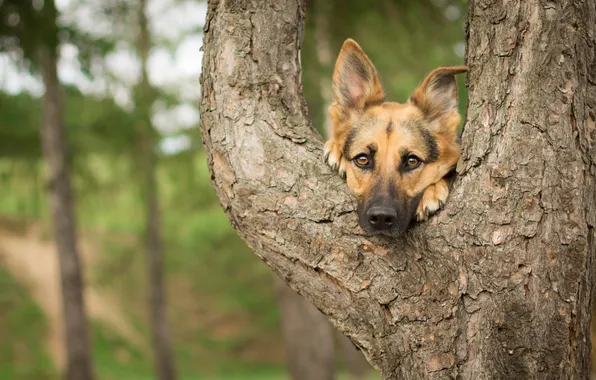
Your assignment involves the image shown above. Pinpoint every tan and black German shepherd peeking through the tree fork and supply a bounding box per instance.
[325,39,468,235]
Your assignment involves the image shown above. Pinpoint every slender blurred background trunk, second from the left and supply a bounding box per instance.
[135,0,176,380]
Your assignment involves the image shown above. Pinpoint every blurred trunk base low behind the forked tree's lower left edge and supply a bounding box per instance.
[274,276,335,380]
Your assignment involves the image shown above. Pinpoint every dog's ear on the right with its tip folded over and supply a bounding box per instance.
[410,66,468,120]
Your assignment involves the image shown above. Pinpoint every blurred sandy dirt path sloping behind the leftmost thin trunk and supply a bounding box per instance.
[0,224,145,369]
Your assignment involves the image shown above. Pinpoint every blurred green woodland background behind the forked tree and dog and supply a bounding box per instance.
[0,0,466,380]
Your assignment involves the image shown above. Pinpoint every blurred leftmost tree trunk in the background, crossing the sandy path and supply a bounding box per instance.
[40,1,93,380]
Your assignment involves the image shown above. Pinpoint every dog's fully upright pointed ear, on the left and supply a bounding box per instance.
[333,39,385,113]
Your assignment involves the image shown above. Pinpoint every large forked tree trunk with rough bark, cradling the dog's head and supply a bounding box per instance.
[200,0,596,380]
